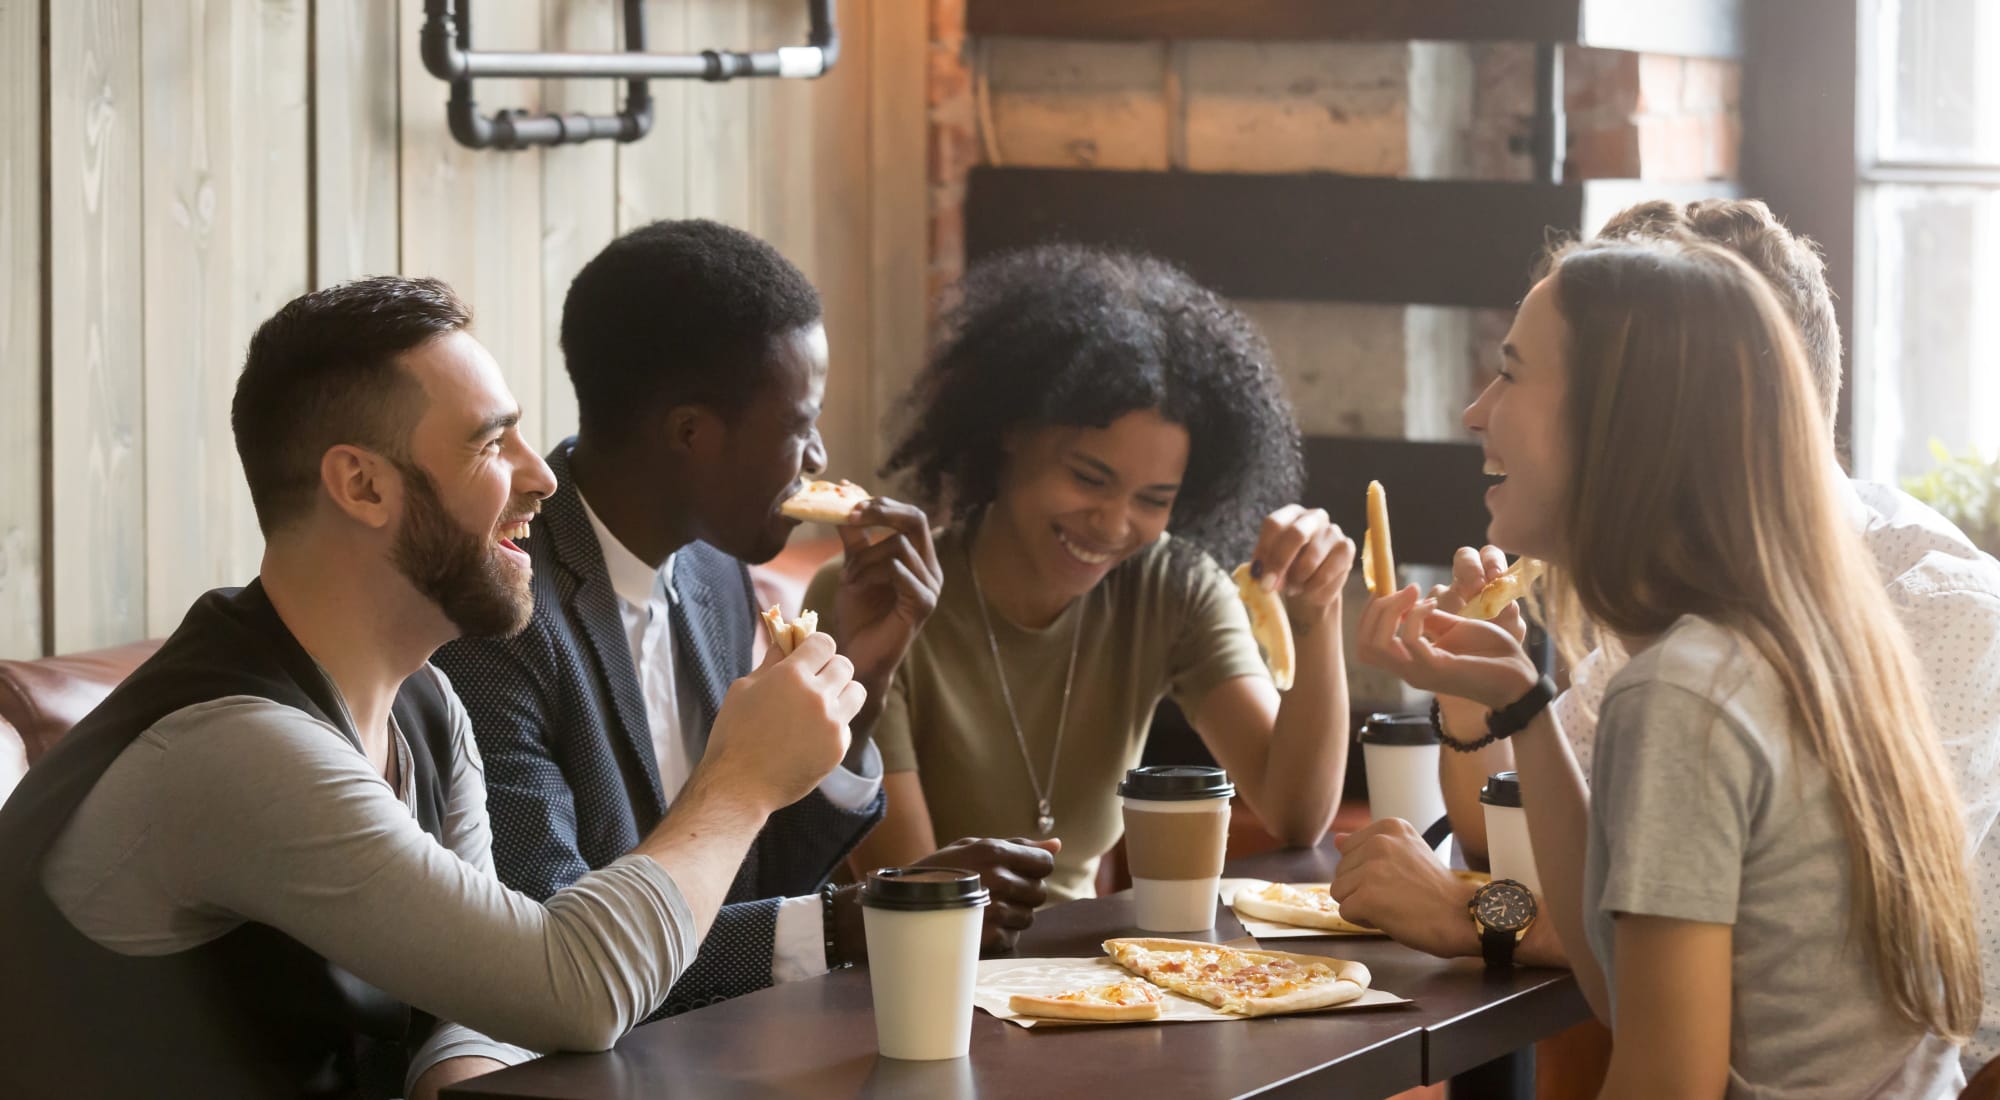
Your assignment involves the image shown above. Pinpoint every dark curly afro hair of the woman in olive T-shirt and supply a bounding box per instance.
[882,244,1302,560]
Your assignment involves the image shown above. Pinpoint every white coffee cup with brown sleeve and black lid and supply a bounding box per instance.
[1118,764,1236,932]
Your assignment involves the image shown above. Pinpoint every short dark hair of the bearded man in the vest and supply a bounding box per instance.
[230,276,472,536]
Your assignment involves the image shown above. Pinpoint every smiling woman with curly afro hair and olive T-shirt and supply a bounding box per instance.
[806,246,1354,900]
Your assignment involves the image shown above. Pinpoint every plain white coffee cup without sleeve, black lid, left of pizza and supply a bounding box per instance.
[862,866,988,1062]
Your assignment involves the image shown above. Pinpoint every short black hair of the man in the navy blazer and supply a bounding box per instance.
[562,220,820,440]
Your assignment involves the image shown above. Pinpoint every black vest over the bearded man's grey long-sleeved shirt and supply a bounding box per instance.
[0,582,452,1098]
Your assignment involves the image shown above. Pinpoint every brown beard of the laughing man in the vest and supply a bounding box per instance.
[390,462,534,638]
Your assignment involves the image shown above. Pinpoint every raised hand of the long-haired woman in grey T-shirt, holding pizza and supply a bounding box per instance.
[1354,584,1540,710]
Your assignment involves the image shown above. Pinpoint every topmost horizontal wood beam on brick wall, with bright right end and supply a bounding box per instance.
[966,0,1742,56]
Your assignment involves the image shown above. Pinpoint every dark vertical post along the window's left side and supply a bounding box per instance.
[1742,0,1860,458]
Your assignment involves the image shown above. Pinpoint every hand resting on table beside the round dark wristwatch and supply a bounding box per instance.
[1330,818,1480,958]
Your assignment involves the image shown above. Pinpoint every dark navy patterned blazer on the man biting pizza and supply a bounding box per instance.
[432,438,882,1014]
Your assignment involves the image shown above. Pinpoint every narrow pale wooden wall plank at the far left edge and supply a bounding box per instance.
[0,0,48,658]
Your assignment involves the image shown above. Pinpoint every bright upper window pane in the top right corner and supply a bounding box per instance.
[1864,0,2000,164]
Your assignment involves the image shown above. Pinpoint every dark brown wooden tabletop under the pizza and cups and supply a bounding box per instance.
[446,844,1588,1100]
